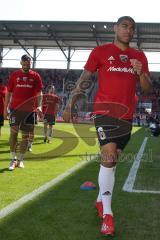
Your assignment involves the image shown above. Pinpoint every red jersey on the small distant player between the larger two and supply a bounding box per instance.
[43,93,59,115]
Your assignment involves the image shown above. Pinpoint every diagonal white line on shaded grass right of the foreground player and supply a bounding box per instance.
[122,137,148,192]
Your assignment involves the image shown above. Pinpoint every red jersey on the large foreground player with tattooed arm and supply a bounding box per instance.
[85,43,149,119]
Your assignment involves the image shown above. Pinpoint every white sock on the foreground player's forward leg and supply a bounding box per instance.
[98,165,115,215]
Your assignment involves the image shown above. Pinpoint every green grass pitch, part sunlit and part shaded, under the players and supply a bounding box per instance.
[0,122,160,240]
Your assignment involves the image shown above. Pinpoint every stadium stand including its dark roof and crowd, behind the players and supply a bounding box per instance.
[0,21,160,125]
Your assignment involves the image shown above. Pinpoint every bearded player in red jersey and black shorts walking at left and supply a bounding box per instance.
[4,55,43,170]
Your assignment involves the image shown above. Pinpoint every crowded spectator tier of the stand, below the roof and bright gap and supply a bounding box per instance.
[0,68,160,126]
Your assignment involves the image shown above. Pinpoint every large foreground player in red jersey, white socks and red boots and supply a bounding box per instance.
[63,16,151,235]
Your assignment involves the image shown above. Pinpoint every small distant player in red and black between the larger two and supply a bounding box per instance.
[43,86,59,143]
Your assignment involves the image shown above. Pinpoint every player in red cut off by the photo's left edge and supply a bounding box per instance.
[0,79,7,136]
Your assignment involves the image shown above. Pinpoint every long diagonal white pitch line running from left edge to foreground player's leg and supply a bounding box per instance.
[0,160,89,219]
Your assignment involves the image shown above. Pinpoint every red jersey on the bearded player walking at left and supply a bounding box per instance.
[8,69,43,111]
